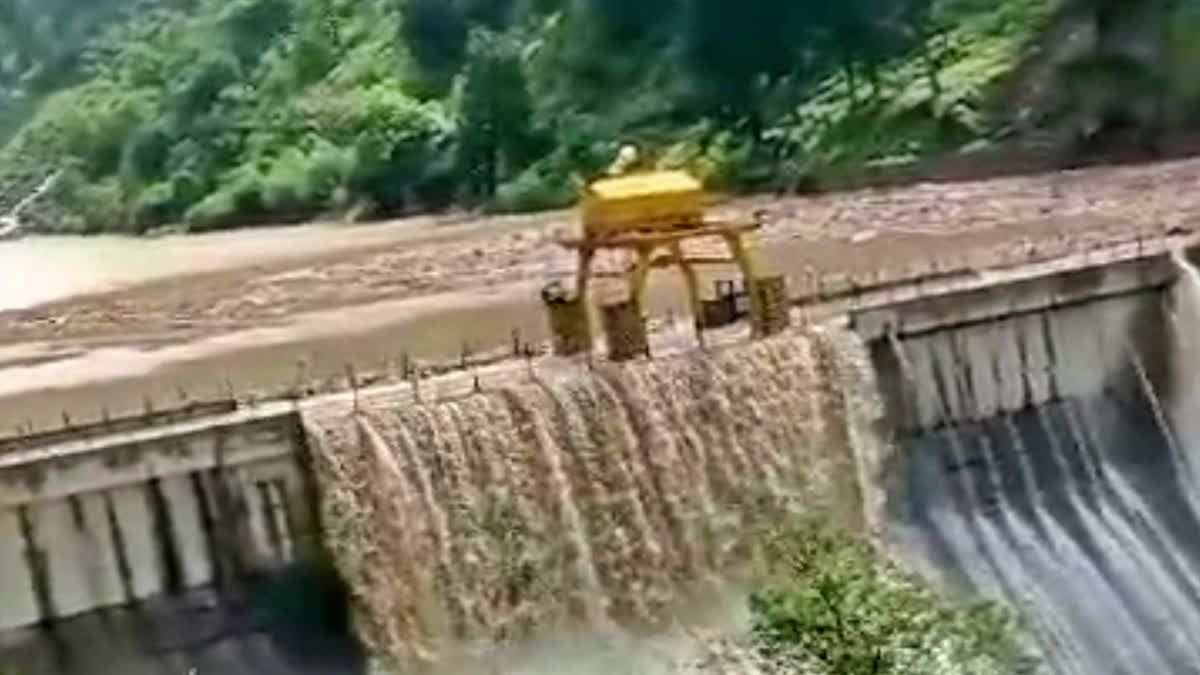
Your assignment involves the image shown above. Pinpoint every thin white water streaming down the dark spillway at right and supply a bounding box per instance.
[889,249,1200,675]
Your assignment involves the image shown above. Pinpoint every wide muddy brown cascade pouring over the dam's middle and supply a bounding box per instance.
[305,329,882,664]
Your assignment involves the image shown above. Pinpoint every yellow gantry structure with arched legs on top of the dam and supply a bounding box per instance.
[544,171,787,360]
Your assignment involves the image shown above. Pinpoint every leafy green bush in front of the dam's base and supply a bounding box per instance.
[750,520,1030,675]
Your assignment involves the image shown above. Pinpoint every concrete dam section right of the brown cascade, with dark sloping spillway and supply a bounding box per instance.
[858,248,1200,675]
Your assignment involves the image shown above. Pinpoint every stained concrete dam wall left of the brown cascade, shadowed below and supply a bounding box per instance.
[0,406,355,675]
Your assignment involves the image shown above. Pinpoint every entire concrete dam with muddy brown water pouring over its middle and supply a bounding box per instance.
[0,235,1200,675]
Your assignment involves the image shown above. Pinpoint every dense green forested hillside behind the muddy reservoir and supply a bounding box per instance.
[0,0,1187,232]
